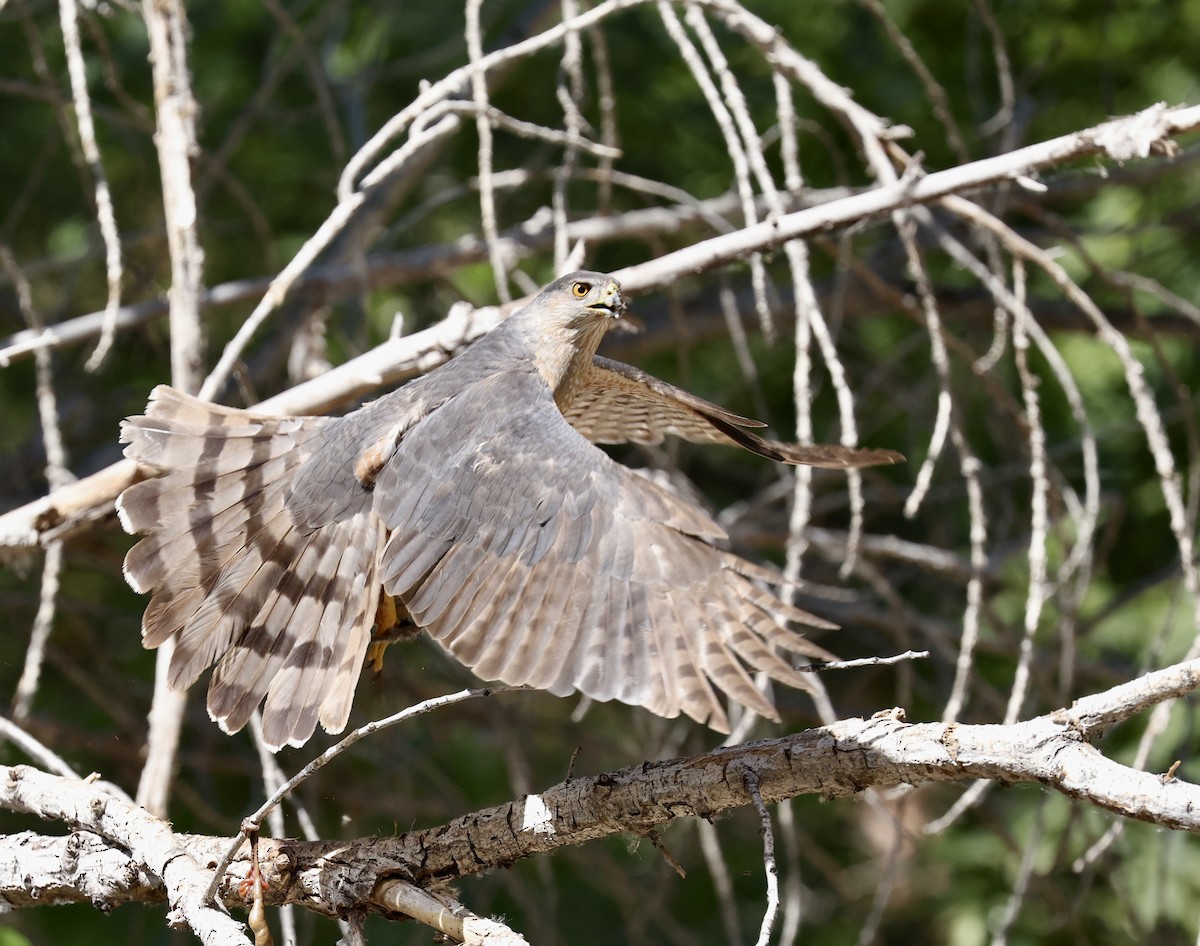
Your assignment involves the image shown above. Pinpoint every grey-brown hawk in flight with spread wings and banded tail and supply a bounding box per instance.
[116,273,899,747]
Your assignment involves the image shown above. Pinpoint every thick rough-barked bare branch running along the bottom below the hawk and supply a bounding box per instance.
[0,660,1200,942]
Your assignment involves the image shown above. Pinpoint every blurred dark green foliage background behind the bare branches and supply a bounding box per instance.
[0,0,1200,946]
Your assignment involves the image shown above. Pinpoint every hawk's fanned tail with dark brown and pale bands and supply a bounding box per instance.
[118,387,383,747]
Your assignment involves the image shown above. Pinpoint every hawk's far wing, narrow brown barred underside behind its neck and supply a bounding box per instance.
[565,355,904,469]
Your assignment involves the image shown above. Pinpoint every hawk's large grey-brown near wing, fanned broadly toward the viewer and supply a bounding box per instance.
[374,369,829,731]
